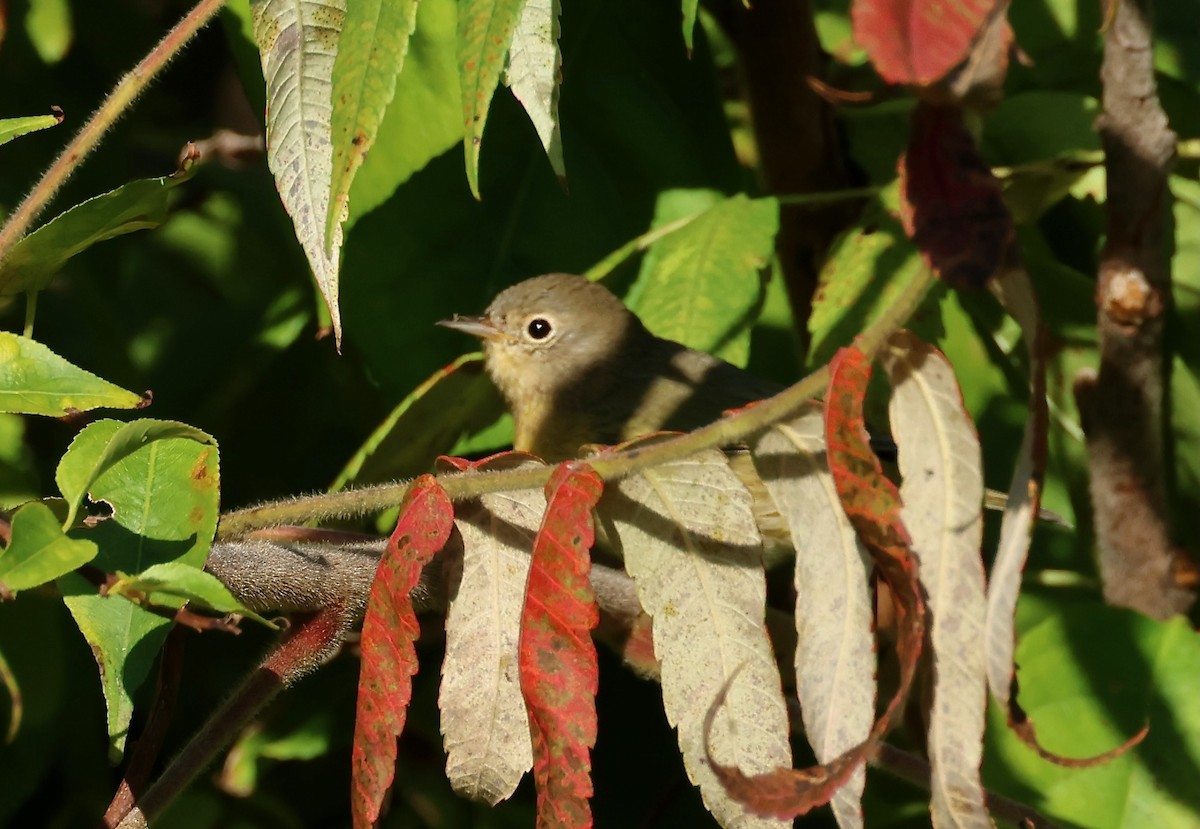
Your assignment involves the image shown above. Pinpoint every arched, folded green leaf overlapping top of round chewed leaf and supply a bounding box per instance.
[54,419,216,527]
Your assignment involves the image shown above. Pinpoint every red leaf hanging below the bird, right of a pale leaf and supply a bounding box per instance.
[520,462,604,829]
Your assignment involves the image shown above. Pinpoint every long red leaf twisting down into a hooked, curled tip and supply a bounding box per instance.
[704,348,925,818]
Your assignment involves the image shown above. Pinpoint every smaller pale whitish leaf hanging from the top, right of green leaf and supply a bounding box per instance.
[504,0,566,181]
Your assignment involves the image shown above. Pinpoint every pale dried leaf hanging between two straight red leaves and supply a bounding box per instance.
[438,455,546,804]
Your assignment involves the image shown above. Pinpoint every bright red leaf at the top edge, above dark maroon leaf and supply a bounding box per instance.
[851,0,998,86]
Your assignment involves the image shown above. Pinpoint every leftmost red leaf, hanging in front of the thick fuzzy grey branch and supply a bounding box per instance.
[350,475,454,828]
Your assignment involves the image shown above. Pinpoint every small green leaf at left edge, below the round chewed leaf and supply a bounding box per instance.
[0,501,96,591]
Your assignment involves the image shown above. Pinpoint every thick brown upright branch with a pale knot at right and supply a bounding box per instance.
[1075,0,1195,619]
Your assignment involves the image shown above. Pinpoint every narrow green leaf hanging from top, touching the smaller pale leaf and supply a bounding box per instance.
[458,0,524,199]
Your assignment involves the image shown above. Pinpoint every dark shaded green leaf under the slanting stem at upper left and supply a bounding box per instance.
[0,164,196,298]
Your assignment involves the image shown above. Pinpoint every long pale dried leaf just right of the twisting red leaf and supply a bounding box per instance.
[884,331,994,829]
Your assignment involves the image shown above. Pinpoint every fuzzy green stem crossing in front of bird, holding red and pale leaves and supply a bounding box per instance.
[217,262,934,541]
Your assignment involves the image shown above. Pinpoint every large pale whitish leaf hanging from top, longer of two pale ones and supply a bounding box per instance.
[251,0,346,346]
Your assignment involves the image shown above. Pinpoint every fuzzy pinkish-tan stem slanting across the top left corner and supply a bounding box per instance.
[0,0,224,260]
